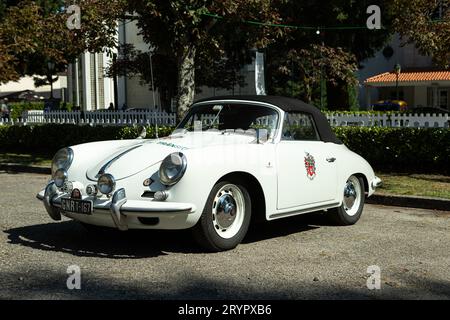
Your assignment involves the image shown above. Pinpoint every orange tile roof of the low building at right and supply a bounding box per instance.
[364,70,450,83]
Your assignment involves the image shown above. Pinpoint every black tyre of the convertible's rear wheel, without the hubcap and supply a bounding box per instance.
[327,176,365,226]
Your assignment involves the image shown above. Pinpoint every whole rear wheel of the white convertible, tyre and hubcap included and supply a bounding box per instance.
[329,176,365,226]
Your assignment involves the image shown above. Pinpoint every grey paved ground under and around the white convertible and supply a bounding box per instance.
[0,173,450,299]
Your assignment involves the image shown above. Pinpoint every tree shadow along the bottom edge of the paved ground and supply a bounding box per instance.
[0,270,450,300]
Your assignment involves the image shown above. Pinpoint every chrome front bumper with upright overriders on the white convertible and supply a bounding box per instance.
[36,181,195,231]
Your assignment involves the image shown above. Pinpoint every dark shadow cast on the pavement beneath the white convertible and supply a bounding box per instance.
[4,215,325,259]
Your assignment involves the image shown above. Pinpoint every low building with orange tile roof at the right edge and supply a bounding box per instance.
[359,36,450,110]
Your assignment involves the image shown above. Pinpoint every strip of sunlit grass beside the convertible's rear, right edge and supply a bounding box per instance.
[377,173,450,199]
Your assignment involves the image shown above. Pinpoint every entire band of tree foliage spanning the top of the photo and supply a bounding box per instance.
[0,0,450,116]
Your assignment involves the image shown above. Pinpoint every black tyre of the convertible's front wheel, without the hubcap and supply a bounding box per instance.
[192,181,252,252]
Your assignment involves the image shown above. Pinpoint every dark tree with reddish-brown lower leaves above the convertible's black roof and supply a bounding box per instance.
[267,0,392,106]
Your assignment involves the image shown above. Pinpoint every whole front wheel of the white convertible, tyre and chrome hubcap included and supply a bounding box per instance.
[193,181,252,252]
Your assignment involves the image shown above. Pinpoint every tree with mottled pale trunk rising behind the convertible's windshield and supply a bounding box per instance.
[124,0,279,117]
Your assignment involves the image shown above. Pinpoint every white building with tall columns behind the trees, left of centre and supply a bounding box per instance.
[67,20,256,111]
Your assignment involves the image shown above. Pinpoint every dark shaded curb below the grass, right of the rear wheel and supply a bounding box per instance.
[366,194,450,211]
